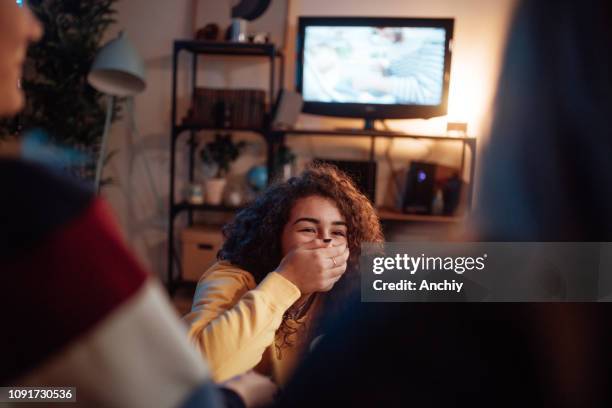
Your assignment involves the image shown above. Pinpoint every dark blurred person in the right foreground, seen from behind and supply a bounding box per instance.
[280,0,612,407]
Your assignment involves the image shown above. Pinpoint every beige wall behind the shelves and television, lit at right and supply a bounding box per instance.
[104,0,514,276]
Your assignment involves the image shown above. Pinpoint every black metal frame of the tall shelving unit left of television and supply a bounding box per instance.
[167,40,284,293]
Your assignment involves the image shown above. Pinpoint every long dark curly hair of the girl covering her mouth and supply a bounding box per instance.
[217,163,383,283]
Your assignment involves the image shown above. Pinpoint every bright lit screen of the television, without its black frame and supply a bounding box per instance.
[302,26,446,105]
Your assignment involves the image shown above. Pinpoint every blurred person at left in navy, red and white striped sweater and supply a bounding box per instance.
[0,0,275,408]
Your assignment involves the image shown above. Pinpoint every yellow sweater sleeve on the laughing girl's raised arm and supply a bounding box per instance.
[185,262,300,381]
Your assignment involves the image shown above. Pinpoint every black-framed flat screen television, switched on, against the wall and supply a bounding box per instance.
[296,17,454,126]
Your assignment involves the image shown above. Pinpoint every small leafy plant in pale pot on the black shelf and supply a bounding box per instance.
[200,133,246,205]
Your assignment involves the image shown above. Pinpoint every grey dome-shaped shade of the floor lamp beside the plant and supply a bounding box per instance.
[87,33,146,96]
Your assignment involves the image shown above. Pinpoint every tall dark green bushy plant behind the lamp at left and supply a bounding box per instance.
[0,0,121,167]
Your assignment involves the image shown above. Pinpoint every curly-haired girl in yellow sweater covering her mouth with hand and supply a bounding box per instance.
[185,164,383,384]
